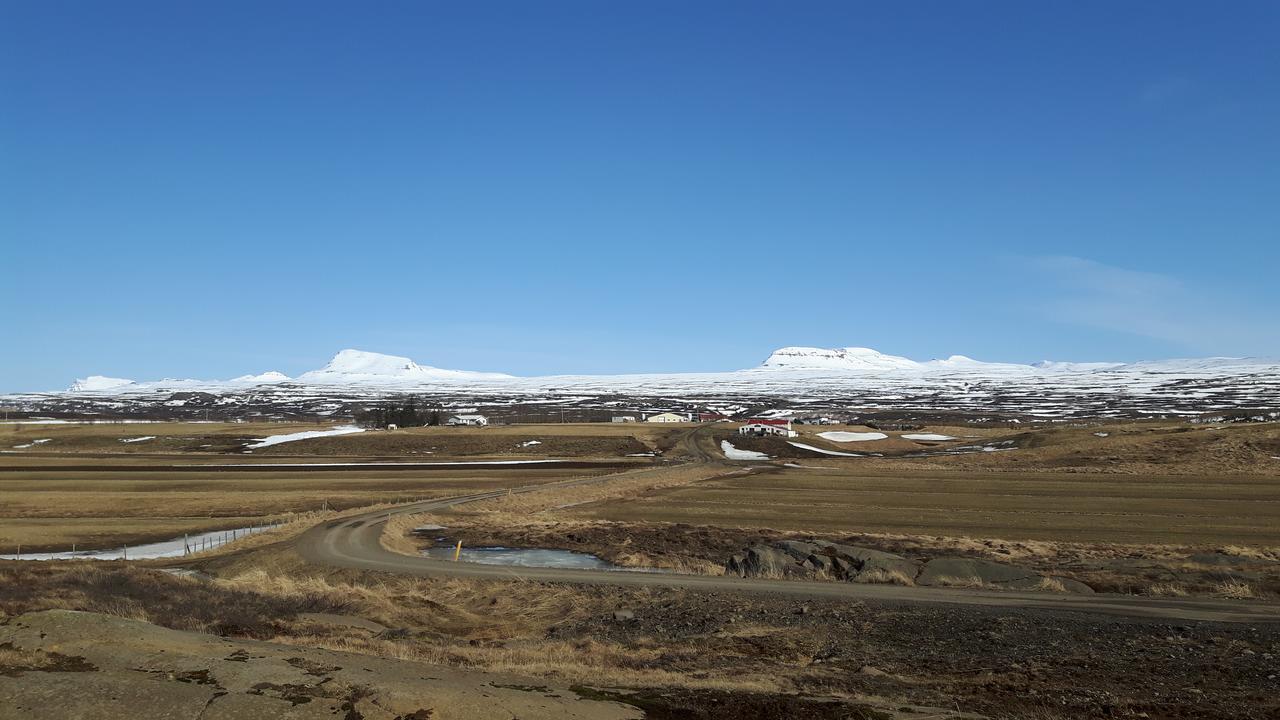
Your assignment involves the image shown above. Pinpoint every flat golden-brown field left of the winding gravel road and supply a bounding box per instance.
[0,423,673,552]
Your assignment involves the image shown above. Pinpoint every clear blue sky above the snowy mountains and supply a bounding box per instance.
[0,0,1280,391]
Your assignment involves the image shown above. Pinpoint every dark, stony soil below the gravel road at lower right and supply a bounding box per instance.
[553,592,1280,719]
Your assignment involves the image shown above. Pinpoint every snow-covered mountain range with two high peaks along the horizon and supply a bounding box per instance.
[5,347,1280,418]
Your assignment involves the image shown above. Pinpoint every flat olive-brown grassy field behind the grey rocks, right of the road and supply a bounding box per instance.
[563,465,1280,546]
